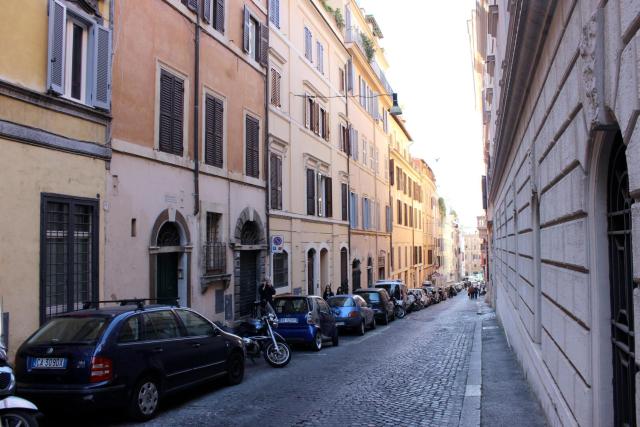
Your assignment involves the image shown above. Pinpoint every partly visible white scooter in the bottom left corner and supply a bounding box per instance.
[0,343,40,427]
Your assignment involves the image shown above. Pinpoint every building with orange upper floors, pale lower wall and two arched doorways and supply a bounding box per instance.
[105,0,269,321]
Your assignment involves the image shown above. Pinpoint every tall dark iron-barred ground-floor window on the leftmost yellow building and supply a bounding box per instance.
[40,195,99,322]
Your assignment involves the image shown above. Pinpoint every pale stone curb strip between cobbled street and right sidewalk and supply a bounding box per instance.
[458,319,482,427]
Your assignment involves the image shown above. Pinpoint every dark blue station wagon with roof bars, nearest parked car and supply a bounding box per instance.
[15,304,245,420]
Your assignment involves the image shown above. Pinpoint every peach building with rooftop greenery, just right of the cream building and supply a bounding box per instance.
[342,0,393,289]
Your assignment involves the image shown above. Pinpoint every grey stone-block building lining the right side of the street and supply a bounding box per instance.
[476,0,640,426]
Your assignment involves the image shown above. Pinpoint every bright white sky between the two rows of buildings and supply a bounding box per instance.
[359,0,484,228]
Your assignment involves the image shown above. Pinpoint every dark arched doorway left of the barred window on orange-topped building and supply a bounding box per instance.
[155,221,187,305]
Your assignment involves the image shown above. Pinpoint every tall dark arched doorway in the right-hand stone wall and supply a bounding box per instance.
[607,132,638,426]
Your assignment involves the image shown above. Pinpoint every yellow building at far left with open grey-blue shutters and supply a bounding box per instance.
[0,0,113,353]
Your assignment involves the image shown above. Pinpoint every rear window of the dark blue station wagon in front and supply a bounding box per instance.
[29,316,109,344]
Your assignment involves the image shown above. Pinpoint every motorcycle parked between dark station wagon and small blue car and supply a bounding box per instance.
[233,302,291,368]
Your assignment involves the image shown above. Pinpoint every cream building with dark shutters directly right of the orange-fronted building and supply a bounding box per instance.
[269,0,351,295]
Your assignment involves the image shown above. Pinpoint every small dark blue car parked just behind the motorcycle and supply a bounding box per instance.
[273,295,338,351]
